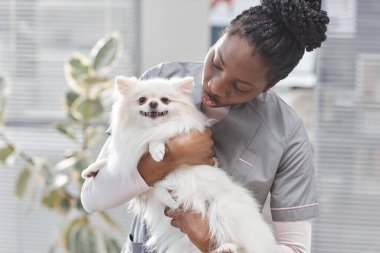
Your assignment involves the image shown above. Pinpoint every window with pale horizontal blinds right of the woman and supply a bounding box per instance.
[313,0,380,253]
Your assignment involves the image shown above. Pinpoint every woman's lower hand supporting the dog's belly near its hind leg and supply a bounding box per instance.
[165,207,214,252]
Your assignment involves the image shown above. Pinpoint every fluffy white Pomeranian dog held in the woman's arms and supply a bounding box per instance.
[82,76,276,253]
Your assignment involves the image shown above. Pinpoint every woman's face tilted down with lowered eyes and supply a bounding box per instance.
[202,34,267,107]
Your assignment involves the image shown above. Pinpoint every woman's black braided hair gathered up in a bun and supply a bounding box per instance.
[225,0,330,89]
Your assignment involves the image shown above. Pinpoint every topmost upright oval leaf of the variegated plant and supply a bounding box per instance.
[90,32,123,74]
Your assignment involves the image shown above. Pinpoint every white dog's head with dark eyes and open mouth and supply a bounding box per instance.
[116,76,194,124]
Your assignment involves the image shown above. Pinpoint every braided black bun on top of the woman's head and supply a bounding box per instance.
[261,0,330,51]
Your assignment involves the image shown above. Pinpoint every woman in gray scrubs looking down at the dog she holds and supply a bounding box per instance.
[82,0,329,252]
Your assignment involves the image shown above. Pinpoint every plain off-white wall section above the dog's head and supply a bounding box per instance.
[140,0,210,72]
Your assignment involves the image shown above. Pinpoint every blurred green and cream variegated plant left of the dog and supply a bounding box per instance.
[0,32,122,253]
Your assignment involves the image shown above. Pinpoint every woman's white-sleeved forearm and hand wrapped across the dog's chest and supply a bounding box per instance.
[81,130,214,212]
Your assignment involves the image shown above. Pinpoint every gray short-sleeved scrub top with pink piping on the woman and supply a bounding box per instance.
[124,62,319,251]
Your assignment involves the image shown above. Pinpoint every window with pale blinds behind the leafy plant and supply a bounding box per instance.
[0,0,139,253]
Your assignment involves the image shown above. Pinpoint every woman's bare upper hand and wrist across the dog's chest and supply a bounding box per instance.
[137,129,215,186]
